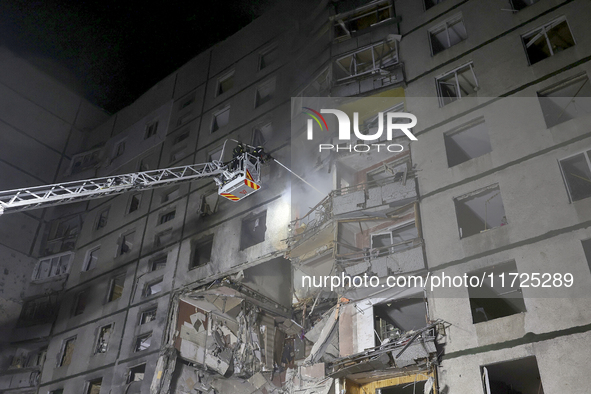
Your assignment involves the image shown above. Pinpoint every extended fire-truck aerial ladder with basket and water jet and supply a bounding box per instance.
[0,141,318,215]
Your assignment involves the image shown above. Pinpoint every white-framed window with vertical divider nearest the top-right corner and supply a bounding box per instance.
[521,17,575,65]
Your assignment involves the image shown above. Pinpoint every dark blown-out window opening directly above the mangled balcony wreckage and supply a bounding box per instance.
[373,298,427,346]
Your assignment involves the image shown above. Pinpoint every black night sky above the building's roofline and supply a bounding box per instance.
[0,0,275,113]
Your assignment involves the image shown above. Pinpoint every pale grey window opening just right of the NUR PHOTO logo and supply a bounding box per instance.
[443,119,492,167]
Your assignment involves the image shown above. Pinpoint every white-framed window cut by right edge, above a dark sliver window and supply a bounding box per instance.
[559,150,591,202]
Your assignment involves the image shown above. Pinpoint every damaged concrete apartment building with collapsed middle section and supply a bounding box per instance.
[0,0,591,394]
